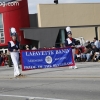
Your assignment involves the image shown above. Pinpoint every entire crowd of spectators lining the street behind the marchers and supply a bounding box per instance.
[0,38,100,67]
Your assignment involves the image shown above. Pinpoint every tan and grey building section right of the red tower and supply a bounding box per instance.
[22,3,100,47]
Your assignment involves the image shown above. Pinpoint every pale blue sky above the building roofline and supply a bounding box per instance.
[28,0,100,14]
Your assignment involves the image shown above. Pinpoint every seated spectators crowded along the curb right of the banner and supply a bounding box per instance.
[74,38,100,62]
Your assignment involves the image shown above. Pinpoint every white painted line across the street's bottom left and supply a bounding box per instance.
[0,94,66,100]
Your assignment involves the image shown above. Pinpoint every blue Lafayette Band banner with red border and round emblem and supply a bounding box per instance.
[21,48,74,71]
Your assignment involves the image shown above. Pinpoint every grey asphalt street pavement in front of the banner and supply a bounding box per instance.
[0,62,100,100]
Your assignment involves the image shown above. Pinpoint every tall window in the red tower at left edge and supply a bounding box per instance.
[0,14,5,43]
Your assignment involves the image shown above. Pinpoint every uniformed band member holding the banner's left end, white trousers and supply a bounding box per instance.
[8,28,23,77]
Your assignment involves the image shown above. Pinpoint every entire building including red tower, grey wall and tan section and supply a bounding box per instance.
[0,0,100,48]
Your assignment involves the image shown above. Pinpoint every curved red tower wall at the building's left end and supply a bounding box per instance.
[0,0,30,46]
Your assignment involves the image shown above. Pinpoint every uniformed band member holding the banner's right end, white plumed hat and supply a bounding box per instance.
[65,27,77,69]
